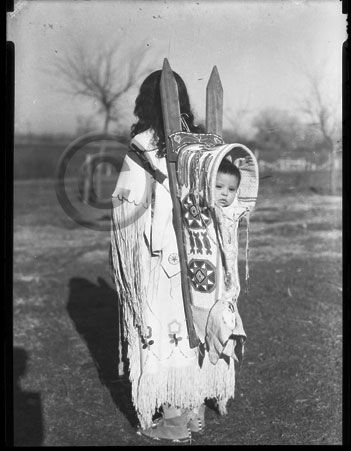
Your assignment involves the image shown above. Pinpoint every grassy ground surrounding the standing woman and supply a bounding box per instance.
[13,177,342,446]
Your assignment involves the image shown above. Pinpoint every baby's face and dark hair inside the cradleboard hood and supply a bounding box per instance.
[215,159,241,207]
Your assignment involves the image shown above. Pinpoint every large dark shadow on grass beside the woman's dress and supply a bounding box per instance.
[67,277,138,426]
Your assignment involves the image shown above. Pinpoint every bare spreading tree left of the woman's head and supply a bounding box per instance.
[55,43,156,195]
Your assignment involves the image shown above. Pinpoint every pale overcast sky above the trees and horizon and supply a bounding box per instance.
[8,0,346,137]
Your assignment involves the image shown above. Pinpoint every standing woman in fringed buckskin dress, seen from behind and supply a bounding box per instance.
[111,70,249,441]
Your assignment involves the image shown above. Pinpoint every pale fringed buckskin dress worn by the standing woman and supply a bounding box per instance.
[111,130,257,428]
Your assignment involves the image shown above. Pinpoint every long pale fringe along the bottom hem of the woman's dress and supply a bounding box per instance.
[124,312,235,428]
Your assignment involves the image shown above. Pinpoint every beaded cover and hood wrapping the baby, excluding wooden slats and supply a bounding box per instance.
[175,132,258,364]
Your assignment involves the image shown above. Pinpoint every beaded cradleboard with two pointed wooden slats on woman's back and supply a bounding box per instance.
[161,59,258,354]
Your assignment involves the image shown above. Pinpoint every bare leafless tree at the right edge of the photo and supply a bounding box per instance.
[299,68,341,194]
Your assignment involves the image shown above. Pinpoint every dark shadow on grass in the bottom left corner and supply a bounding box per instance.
[13,348,43,446]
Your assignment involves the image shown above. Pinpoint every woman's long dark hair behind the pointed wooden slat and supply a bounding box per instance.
[131,70,204,157]
